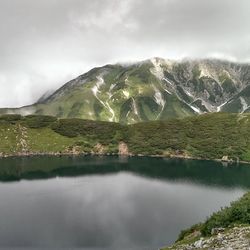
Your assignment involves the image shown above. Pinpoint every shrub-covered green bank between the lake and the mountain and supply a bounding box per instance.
[0,113,250,161]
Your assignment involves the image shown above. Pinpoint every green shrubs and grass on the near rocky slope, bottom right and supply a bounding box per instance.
[163,192,250,250]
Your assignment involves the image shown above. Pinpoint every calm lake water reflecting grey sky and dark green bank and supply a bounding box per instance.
[0,157,250,250]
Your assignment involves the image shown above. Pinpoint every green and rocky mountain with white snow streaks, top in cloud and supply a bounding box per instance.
[0,58,250,124]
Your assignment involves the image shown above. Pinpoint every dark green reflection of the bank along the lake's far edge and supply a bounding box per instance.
[0,156,250,188]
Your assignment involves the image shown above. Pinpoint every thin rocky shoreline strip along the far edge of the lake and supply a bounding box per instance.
[0,152,250,165]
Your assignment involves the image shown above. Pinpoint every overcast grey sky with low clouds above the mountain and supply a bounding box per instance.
[0,0,250,107]
